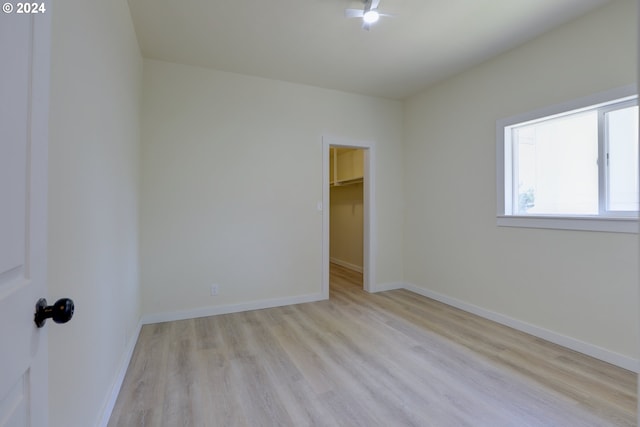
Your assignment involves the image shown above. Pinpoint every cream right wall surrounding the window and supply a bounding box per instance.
[404,0,638,359]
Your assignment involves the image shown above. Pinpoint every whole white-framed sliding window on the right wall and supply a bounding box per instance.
[497,87,639,232]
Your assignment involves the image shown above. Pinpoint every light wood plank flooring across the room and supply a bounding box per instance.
[109,265,636,427]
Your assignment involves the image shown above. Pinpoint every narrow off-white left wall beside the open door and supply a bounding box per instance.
[47,0,142,427]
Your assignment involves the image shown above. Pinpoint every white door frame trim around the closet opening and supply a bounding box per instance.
[322,135,376,299]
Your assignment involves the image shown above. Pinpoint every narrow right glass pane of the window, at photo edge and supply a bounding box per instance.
[605,106,638,211]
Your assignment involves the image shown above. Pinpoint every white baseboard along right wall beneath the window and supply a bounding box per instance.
[404,283,640,373]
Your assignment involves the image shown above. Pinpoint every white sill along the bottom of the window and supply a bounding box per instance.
[496,215,638,233]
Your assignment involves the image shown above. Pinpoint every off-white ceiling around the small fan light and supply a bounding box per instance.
[129,0,614,99]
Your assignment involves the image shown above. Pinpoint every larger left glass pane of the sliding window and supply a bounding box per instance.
[512,111,598,215]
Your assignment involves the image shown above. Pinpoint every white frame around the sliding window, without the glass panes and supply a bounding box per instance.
[496,85,638,233]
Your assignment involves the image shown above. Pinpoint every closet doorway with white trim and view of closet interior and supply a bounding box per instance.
[322,137,374,299]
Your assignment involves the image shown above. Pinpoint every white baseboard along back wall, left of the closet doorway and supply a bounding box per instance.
[142,293,326,325]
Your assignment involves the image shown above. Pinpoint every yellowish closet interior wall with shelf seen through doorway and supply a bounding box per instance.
[329,147,364,272]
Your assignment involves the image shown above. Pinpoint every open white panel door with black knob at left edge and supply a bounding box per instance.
[0,4,51,427]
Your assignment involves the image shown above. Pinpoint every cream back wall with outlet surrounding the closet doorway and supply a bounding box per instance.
[141,59,403,319]
